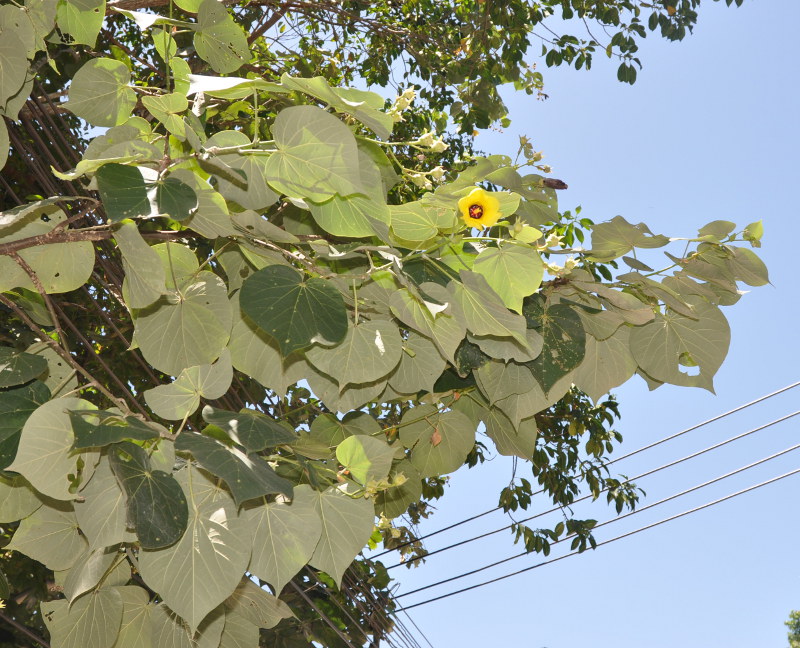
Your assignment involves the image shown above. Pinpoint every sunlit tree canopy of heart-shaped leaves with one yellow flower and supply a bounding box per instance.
[0,0,768,648]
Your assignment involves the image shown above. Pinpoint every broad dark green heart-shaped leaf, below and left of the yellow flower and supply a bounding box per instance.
[239,265,347,357]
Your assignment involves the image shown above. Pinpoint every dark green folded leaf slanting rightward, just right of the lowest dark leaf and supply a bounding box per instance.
[175,432,292,506]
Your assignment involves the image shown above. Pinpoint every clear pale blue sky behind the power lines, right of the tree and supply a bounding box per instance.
[387,0,800,648]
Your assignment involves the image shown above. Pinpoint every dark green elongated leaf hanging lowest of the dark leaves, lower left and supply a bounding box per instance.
[109,441,189,549]
